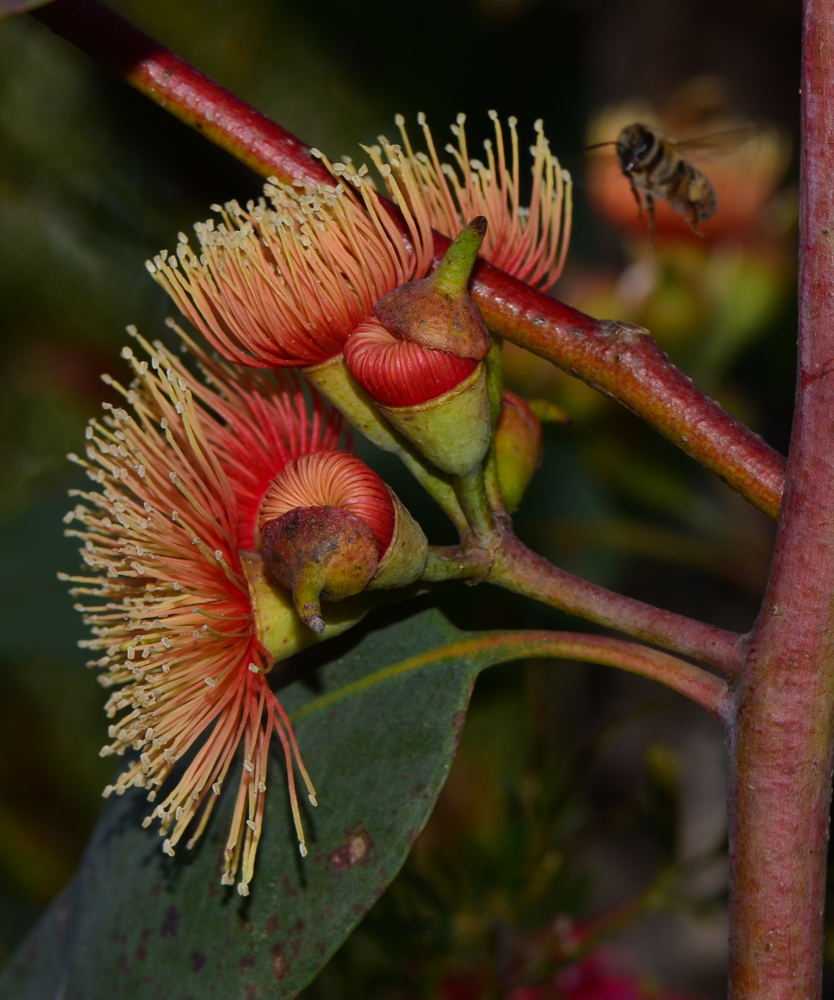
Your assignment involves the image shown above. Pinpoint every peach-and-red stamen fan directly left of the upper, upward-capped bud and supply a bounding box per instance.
[147,164,433,368]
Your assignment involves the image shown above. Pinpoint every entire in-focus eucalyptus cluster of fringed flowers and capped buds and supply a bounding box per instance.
[65,111,569,895]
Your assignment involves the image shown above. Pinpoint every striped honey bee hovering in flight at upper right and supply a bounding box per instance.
[588,123,718,241]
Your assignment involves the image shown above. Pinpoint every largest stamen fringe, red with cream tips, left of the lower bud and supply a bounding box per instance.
[64,324,348,895]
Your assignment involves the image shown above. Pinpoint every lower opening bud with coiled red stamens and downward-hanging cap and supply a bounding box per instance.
[259,452,428,634]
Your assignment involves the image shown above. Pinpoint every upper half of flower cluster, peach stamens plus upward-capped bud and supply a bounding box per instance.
[148,112,571,532]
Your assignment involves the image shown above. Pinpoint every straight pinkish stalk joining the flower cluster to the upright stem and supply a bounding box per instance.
[489,531,744,674]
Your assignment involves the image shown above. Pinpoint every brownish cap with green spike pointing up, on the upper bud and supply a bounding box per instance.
[374,215,489,361]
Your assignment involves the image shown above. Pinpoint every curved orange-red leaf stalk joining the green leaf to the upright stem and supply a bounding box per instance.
[474,632,727,719]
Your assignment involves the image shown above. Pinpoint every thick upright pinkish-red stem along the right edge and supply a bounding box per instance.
[730,0,834,1000]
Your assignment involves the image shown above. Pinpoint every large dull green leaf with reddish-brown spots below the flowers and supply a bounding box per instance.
[0,611,523,1000]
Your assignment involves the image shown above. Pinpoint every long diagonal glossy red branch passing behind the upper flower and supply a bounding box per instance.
[33,0,784,517]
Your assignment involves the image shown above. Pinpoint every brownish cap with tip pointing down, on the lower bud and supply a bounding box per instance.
[263,507,379,635]
